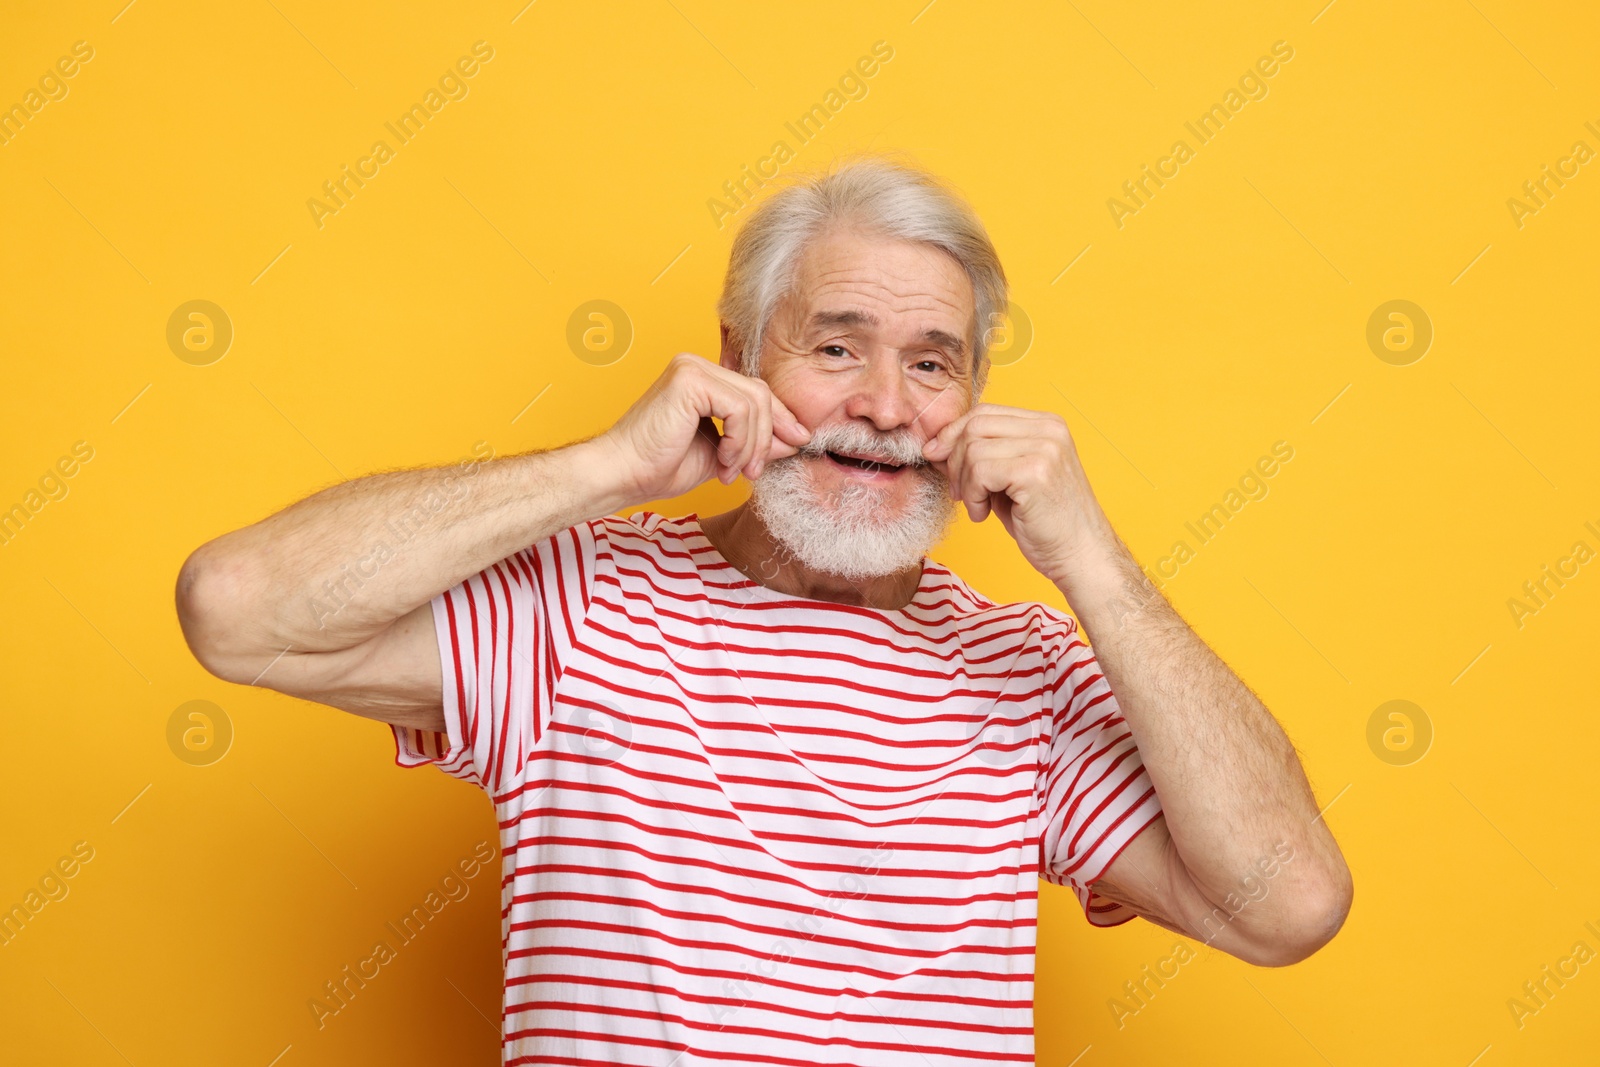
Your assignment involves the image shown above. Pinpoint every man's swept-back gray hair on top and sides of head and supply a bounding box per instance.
[717,155,1010,402]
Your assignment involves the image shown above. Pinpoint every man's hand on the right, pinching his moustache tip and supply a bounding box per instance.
[923,403,1117,585]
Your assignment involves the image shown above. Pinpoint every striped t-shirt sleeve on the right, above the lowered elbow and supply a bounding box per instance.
[1038,616,1162,926]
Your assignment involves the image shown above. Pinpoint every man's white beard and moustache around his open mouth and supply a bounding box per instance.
[750,424,958,581]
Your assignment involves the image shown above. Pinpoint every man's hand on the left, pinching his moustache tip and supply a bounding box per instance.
[595,352,811,506]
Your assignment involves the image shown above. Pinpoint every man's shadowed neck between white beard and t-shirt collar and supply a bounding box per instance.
[701,502,922,611]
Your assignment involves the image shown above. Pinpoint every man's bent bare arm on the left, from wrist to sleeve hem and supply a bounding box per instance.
[176,435,632,731]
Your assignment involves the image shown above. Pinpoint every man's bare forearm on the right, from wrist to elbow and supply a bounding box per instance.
[1059,534,1346,926]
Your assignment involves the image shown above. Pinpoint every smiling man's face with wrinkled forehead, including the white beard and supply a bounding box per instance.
[722,223,973,576]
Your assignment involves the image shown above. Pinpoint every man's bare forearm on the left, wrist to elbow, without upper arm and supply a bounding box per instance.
[178,438,632,662]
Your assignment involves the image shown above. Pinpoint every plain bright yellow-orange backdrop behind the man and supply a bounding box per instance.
[0,0,1600,1067]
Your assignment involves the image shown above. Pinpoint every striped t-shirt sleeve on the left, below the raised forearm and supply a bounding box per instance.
[392,518,610,797]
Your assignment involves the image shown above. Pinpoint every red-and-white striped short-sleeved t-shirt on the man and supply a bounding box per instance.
[394,510,1162,1067]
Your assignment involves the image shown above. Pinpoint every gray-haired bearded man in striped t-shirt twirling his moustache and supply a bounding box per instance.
[178,157,1352,1067]
